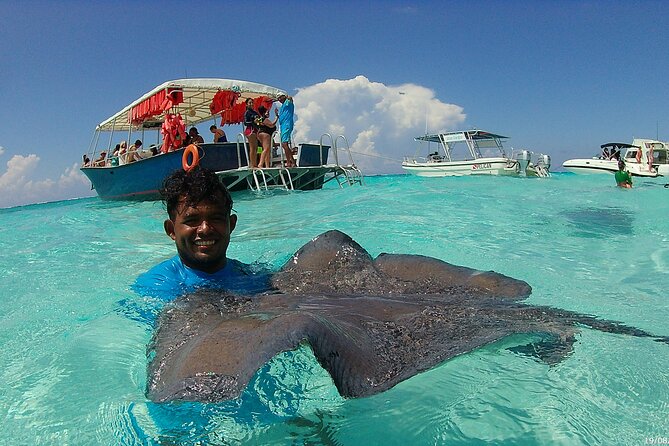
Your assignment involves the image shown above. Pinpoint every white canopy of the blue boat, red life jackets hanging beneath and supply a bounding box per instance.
[96,78,286,131]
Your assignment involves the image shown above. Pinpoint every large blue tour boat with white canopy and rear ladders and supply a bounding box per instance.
[81,79,363,200]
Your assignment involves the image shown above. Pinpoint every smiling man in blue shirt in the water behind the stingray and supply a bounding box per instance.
[132,166,269,301]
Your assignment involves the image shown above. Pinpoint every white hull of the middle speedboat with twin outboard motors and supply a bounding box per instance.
[402,158,519,177]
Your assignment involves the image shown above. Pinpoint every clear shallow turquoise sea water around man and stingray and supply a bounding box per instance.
[0,174,669,445]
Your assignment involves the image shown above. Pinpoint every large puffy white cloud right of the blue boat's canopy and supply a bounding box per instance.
[293,76,466,174]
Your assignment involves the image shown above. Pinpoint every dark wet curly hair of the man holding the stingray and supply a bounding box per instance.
[160,166,232,220]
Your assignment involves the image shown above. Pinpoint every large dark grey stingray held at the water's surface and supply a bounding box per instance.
[147,231,669,402]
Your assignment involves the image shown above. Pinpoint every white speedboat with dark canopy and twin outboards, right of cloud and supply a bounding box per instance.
[402,130,550,177]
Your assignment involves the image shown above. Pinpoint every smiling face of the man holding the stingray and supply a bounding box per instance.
[165,197,237,274]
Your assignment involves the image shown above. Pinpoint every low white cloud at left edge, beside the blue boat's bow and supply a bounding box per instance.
[0,151,90,208]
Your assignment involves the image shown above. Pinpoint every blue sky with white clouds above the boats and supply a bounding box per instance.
[0,0,669,207]
